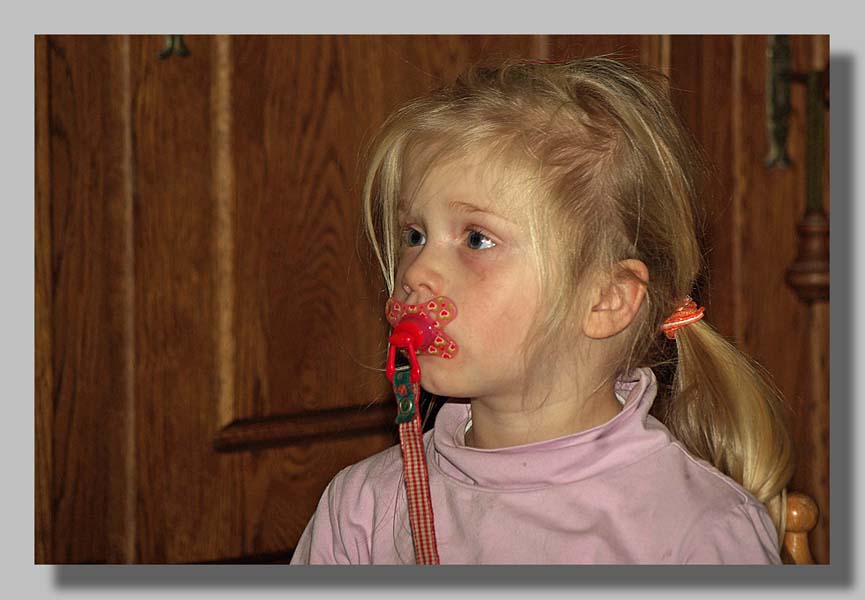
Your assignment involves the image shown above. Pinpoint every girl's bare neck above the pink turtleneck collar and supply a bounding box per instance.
[465,382,622,449]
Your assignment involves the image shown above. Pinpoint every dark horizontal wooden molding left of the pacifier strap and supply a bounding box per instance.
[213,401,396,452]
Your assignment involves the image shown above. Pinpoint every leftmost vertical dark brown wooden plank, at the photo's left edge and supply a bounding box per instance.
[40,36,130,563]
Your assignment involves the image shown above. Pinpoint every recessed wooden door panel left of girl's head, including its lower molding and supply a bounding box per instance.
[218,36,536,448]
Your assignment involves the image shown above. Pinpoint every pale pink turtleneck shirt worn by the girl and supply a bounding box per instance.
[292,369,781,564]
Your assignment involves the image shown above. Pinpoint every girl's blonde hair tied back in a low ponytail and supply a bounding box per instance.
[363,57,793,537]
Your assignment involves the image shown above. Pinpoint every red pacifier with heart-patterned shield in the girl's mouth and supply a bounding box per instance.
[385,296,459,383]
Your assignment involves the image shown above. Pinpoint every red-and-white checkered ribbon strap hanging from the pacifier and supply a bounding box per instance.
[393,368,439,565]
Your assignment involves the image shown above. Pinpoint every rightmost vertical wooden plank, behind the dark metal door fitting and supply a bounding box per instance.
[740,36,829,564]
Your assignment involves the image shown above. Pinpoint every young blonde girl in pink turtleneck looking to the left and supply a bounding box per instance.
[292,58,793,564]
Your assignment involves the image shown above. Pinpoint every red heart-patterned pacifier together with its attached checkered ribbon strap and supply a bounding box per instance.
[385,296,458,565]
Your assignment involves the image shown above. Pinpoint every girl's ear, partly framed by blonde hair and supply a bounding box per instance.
[583,259,649,339]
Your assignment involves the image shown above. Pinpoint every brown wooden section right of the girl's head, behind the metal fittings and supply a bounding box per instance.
[670,36,829,563]
